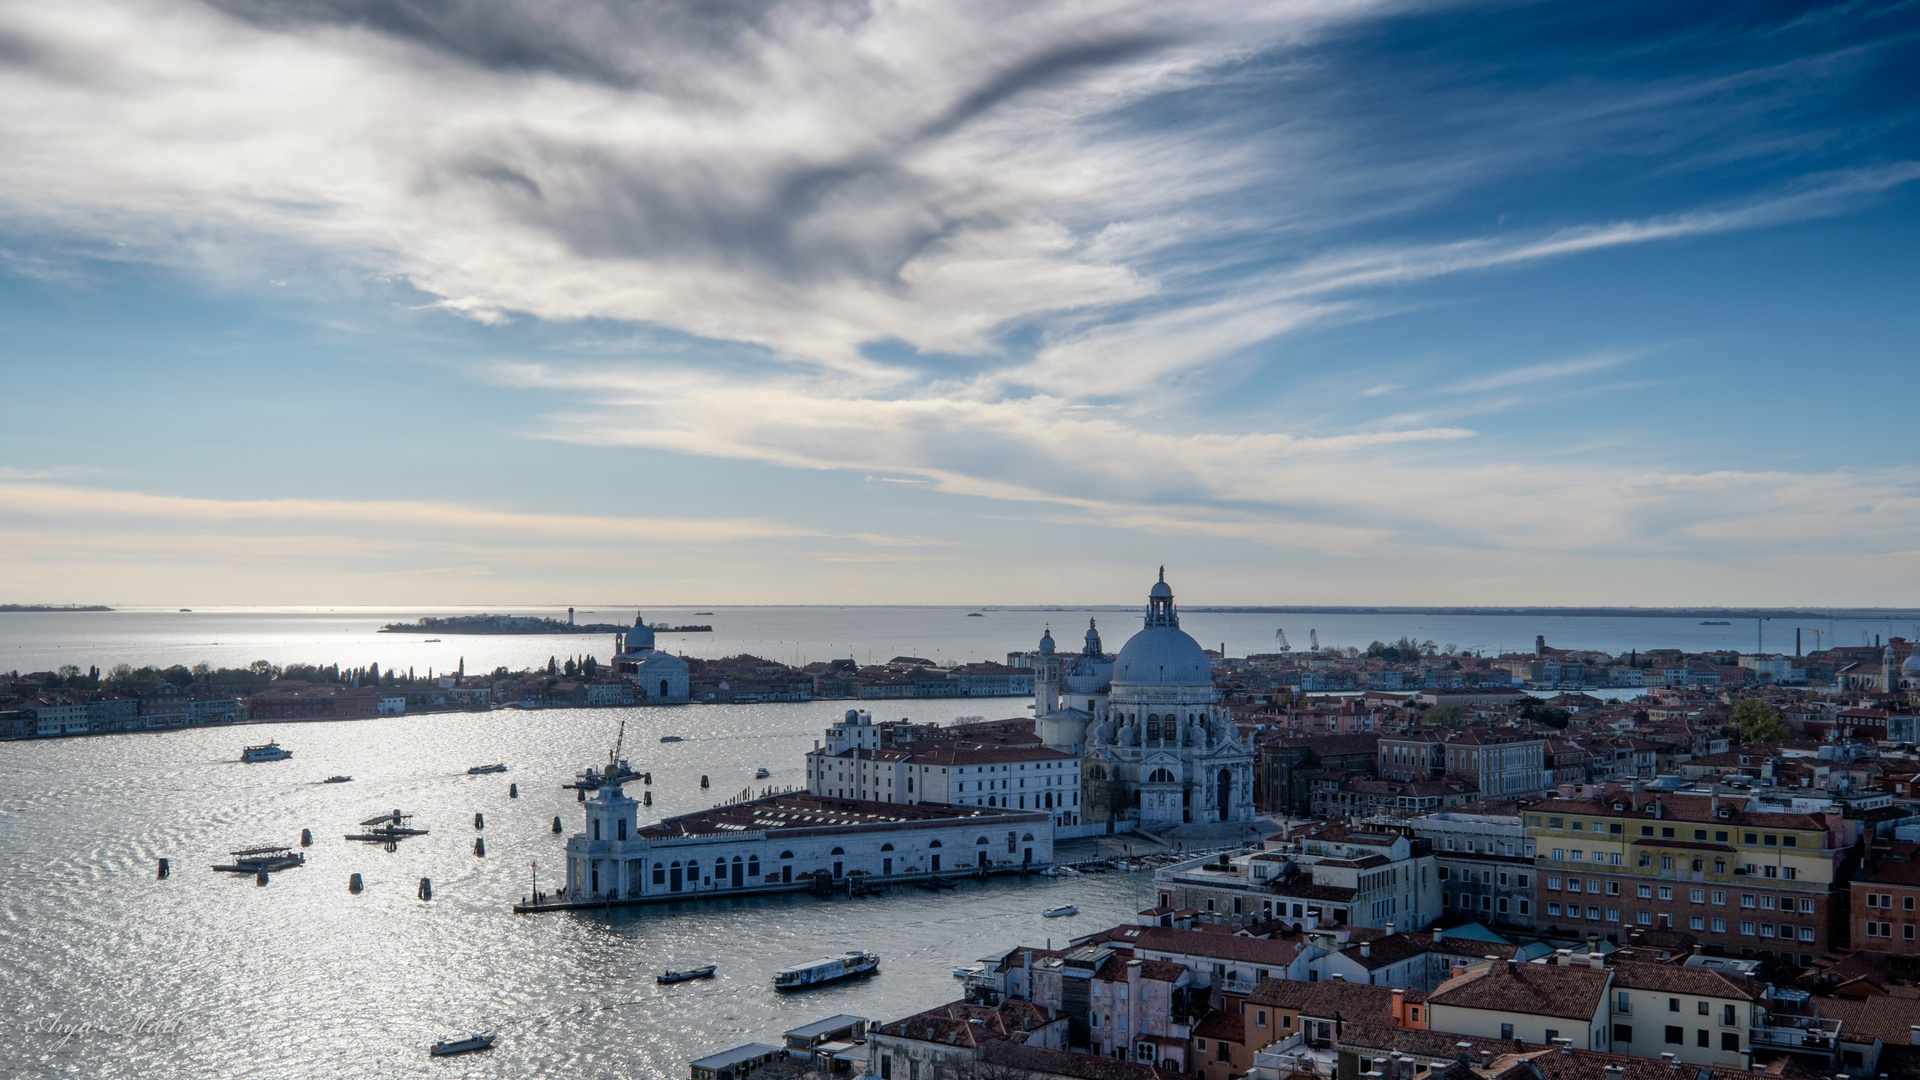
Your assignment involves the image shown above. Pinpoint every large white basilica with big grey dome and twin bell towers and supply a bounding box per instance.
[1033,567,1254,832]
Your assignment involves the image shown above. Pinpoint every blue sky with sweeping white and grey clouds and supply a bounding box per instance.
[0,0,1920,607]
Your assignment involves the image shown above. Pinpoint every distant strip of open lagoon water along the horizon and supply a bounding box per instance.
[0,598,1920,676]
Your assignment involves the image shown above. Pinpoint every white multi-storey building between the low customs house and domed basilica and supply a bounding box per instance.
[806,709,1081,836]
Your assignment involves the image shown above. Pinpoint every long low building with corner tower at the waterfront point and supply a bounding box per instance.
[566,784,1054,901]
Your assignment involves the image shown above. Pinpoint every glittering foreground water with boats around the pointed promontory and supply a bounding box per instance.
[0,701,1152,1078]
